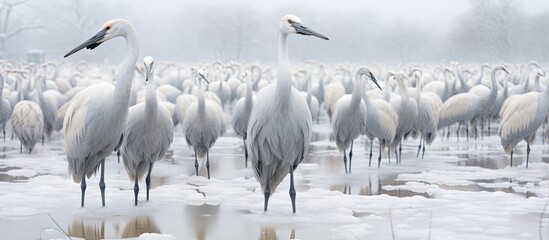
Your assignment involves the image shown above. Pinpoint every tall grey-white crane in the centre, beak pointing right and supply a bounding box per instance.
[246,15,328,213]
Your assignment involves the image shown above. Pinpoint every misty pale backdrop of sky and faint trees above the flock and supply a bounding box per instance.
[0,0,549,64]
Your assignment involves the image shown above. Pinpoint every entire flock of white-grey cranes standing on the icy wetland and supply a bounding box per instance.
[0,15,549,213]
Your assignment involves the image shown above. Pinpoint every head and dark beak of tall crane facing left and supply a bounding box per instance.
[63,18,133,58]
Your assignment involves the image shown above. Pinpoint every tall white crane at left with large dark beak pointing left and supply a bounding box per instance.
[63,19,139,207]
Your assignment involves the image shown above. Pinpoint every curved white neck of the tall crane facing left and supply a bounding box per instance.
[113,27,139,112]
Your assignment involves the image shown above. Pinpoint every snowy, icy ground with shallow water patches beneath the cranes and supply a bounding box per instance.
[0,116,549,240]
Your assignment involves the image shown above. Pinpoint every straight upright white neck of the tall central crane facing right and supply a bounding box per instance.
[275,32,292,109]
